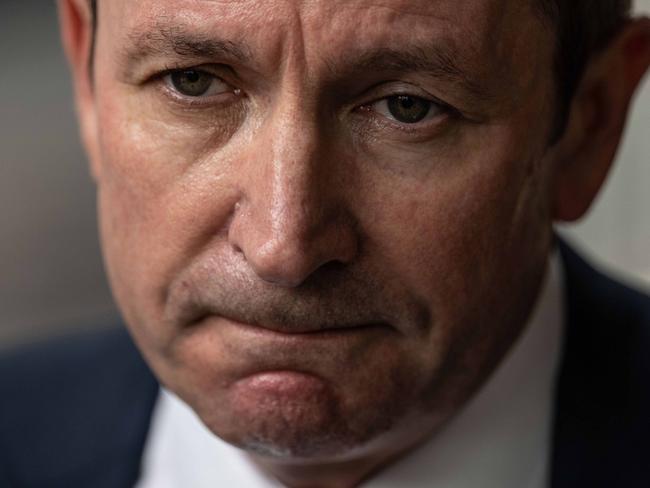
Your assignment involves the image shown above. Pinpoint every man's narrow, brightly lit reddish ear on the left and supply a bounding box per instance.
[58,0,99,179]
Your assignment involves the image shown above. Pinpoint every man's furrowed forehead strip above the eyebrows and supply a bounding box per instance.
[99,0,544,61]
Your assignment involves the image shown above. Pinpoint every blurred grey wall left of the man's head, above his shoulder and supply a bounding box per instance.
[0,0,114,345]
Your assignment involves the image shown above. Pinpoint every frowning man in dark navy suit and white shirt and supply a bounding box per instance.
[0,0,650,487]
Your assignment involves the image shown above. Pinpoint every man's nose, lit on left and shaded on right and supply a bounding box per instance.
[228,103,358,287]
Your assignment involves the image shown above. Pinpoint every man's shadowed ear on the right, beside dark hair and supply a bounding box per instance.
[552,18,650,221]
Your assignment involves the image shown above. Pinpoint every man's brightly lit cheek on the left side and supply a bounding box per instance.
[93,86,243,341]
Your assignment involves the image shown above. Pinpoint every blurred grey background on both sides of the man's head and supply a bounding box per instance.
[0,0,650,348]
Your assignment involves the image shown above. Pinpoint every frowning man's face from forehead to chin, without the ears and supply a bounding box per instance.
[85,0,554,459]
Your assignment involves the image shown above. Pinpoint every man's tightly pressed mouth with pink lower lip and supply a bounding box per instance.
[175,314,400,396]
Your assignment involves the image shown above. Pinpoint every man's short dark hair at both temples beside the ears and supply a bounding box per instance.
[90,0,632,140]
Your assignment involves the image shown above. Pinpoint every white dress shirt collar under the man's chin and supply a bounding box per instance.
[137,254,564,488]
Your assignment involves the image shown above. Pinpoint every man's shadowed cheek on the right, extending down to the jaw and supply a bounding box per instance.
[354,140,551,408]
